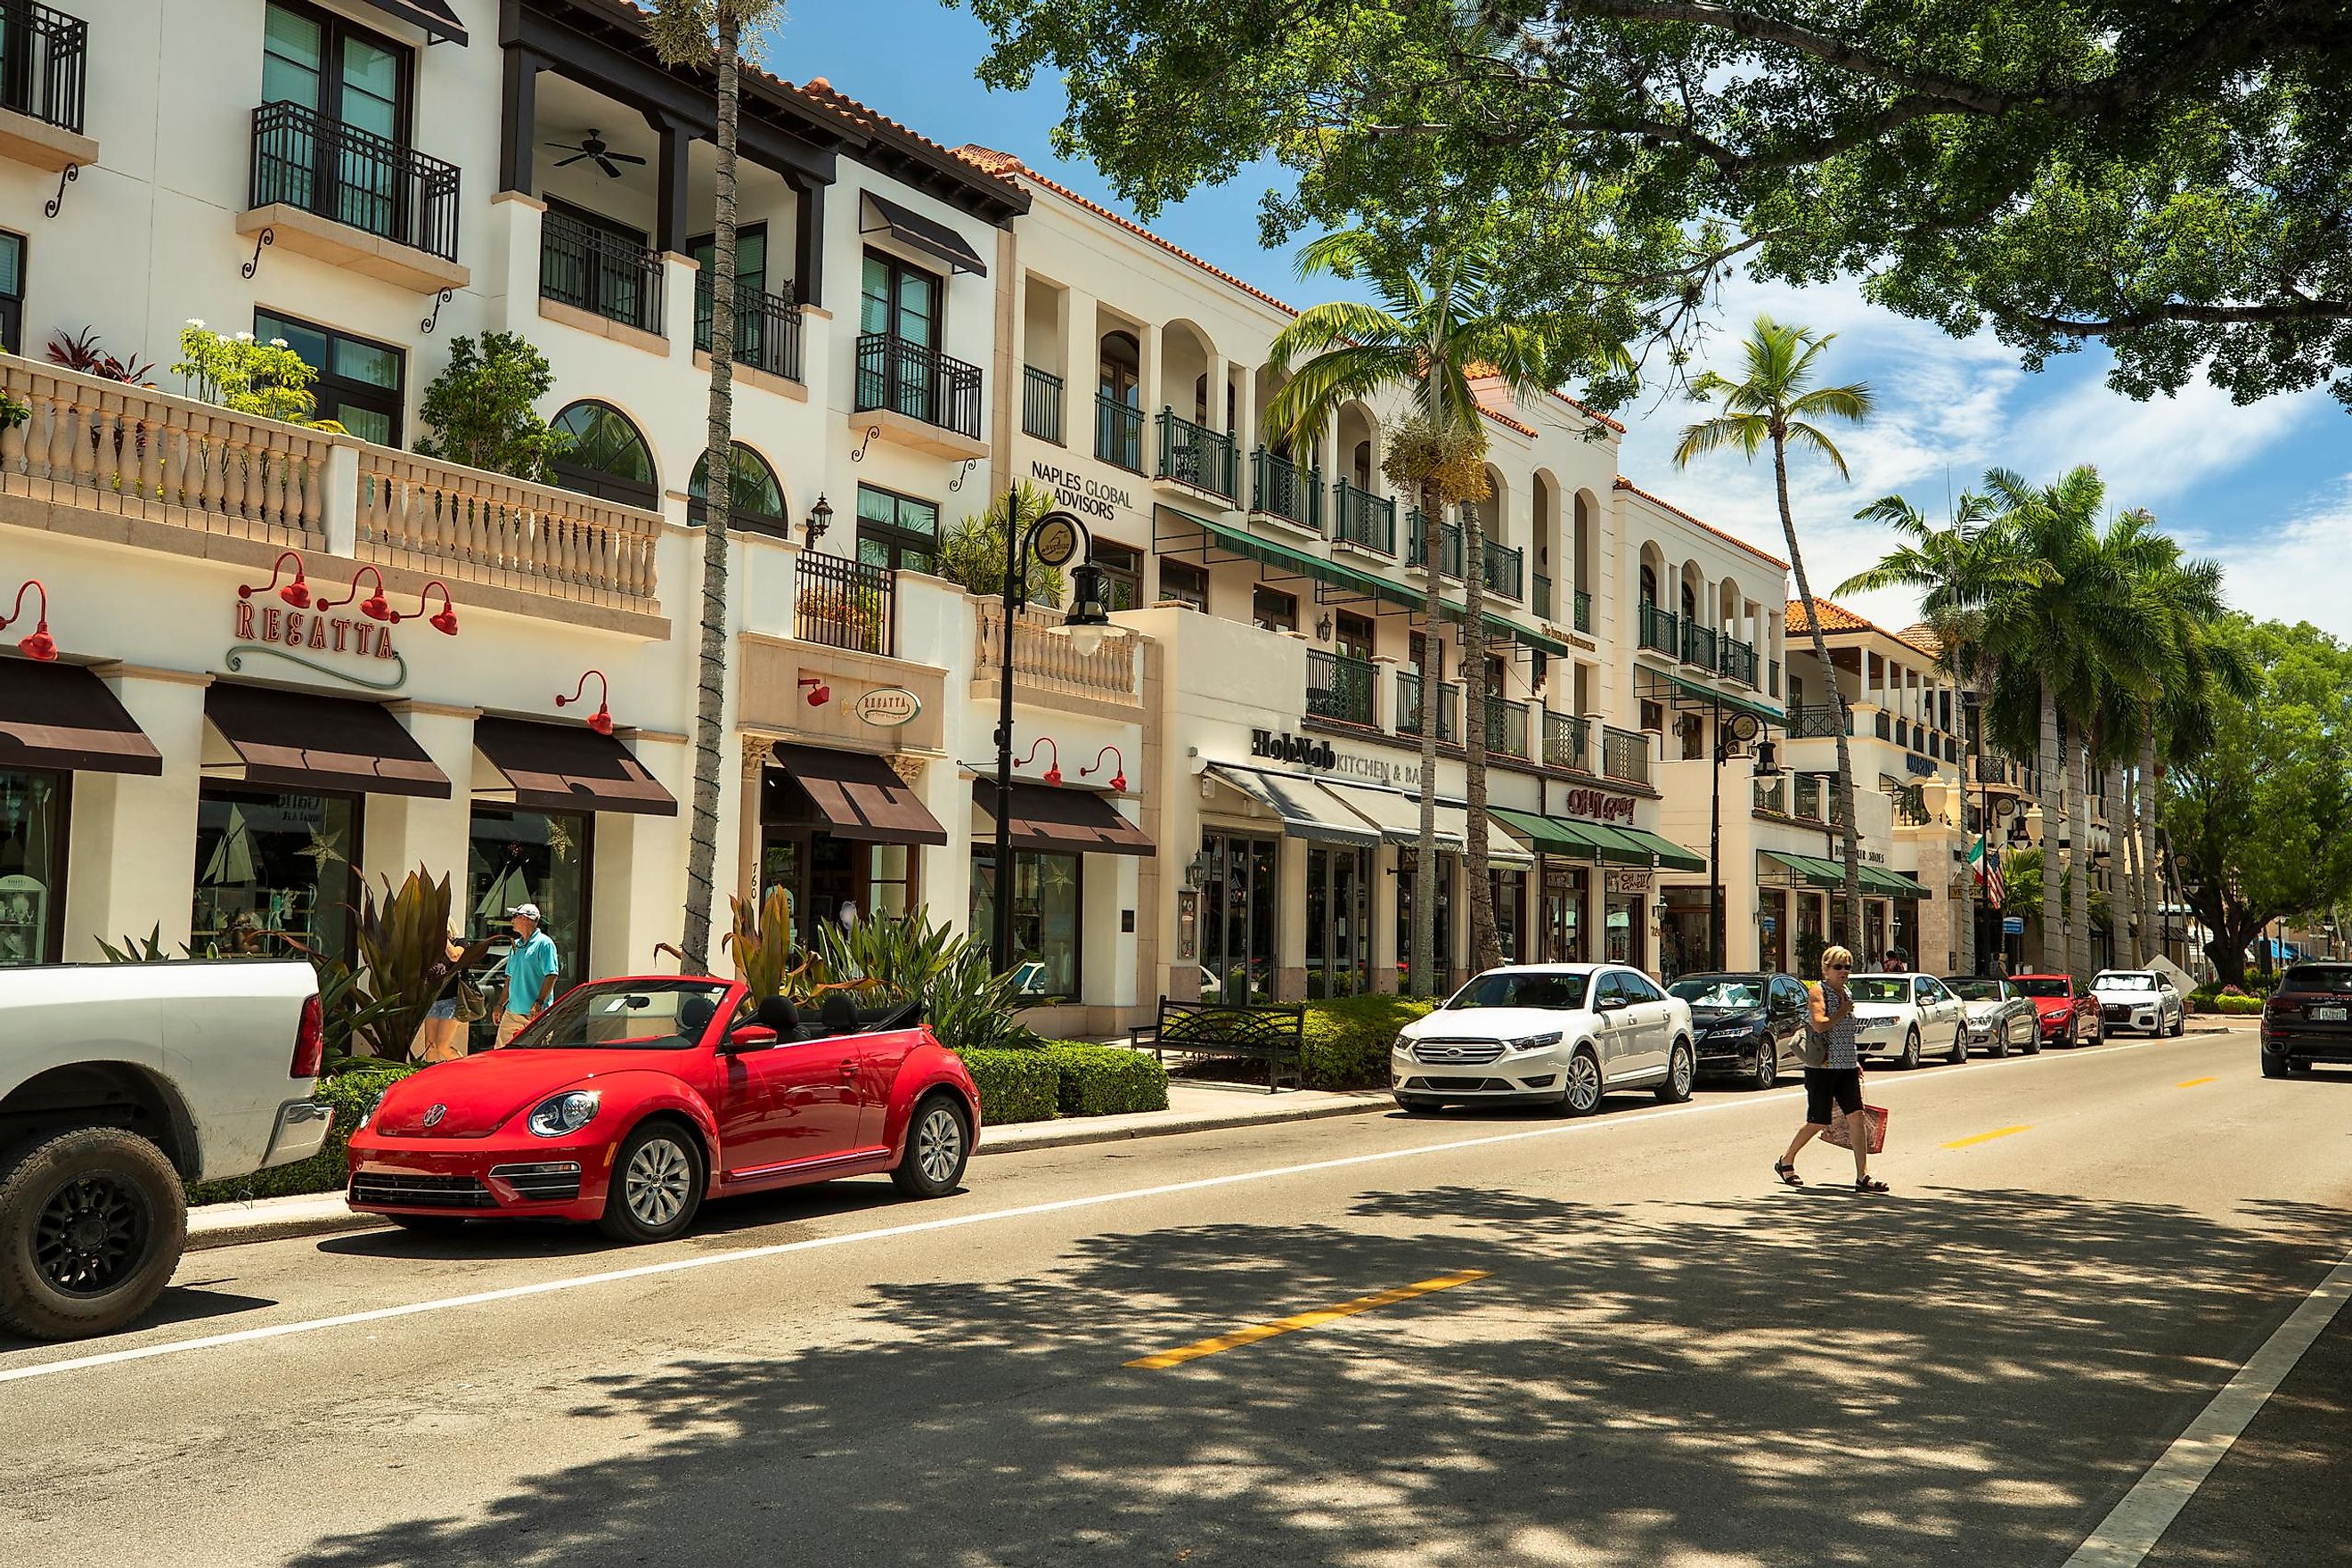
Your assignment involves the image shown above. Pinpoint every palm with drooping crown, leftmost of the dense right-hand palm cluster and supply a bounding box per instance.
[1837,491,2048,973]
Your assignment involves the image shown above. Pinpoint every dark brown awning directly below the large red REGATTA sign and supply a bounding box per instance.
[205,682,449,799]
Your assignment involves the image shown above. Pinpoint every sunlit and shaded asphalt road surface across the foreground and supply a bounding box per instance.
[0,1032,2352,1568]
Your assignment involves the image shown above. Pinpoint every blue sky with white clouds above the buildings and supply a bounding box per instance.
[762,0,2352,637]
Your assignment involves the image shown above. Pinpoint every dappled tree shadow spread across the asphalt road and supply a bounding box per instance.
[297,1185,2352,1568]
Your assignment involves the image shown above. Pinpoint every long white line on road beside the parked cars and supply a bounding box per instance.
[0,1039,2239,1383]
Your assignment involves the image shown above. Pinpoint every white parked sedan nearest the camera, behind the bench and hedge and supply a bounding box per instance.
[1390,964,1698,1116]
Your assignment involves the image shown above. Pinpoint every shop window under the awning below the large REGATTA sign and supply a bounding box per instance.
[191,783,363,961]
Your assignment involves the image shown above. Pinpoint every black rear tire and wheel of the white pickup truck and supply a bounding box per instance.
[0,1126,188,1340]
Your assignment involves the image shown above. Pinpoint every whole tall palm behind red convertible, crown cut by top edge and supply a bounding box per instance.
[649,0,783,971]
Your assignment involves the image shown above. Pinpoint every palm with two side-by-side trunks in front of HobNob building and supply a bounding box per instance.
[1265,228,1555,997]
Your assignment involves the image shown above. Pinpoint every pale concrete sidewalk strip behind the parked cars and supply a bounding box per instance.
[188,1083,1395,1253]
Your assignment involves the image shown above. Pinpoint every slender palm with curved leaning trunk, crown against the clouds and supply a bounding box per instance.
[1675,315,1872,940]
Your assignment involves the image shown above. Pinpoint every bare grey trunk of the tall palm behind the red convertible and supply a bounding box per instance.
[680,4,738,973]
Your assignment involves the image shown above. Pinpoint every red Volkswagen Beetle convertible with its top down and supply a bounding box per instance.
[350,976,981,1241]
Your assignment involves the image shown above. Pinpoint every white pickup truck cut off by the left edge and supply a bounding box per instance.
[0,960,334,1340]
